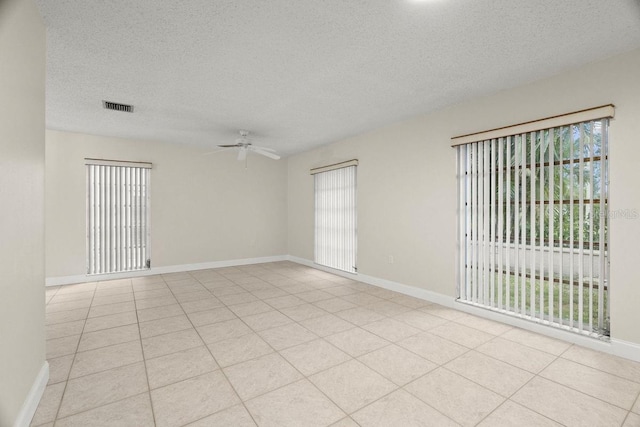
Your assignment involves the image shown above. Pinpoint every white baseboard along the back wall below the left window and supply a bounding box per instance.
[45,255,287,286]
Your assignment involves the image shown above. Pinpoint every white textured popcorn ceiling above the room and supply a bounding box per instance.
[36,0,640,155]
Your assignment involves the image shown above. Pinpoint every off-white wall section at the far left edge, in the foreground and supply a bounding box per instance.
[0,0,46,426]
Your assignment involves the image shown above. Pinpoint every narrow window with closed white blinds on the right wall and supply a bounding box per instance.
[311,160,358,273]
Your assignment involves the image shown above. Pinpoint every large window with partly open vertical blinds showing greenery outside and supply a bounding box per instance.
[453,106,613,336]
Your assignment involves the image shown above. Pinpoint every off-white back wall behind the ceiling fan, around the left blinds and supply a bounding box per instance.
[46,132,287,278]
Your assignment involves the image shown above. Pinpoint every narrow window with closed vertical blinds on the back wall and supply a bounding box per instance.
[85,159,151,274]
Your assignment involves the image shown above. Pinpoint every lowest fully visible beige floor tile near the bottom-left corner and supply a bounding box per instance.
[59,362,148,418]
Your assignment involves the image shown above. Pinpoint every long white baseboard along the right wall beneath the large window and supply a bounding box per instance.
[287,255,640,362]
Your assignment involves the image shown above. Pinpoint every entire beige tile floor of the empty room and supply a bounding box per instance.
[33,262,640,427]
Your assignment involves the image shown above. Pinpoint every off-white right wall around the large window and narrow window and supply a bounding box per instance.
[288,50,640,344]
